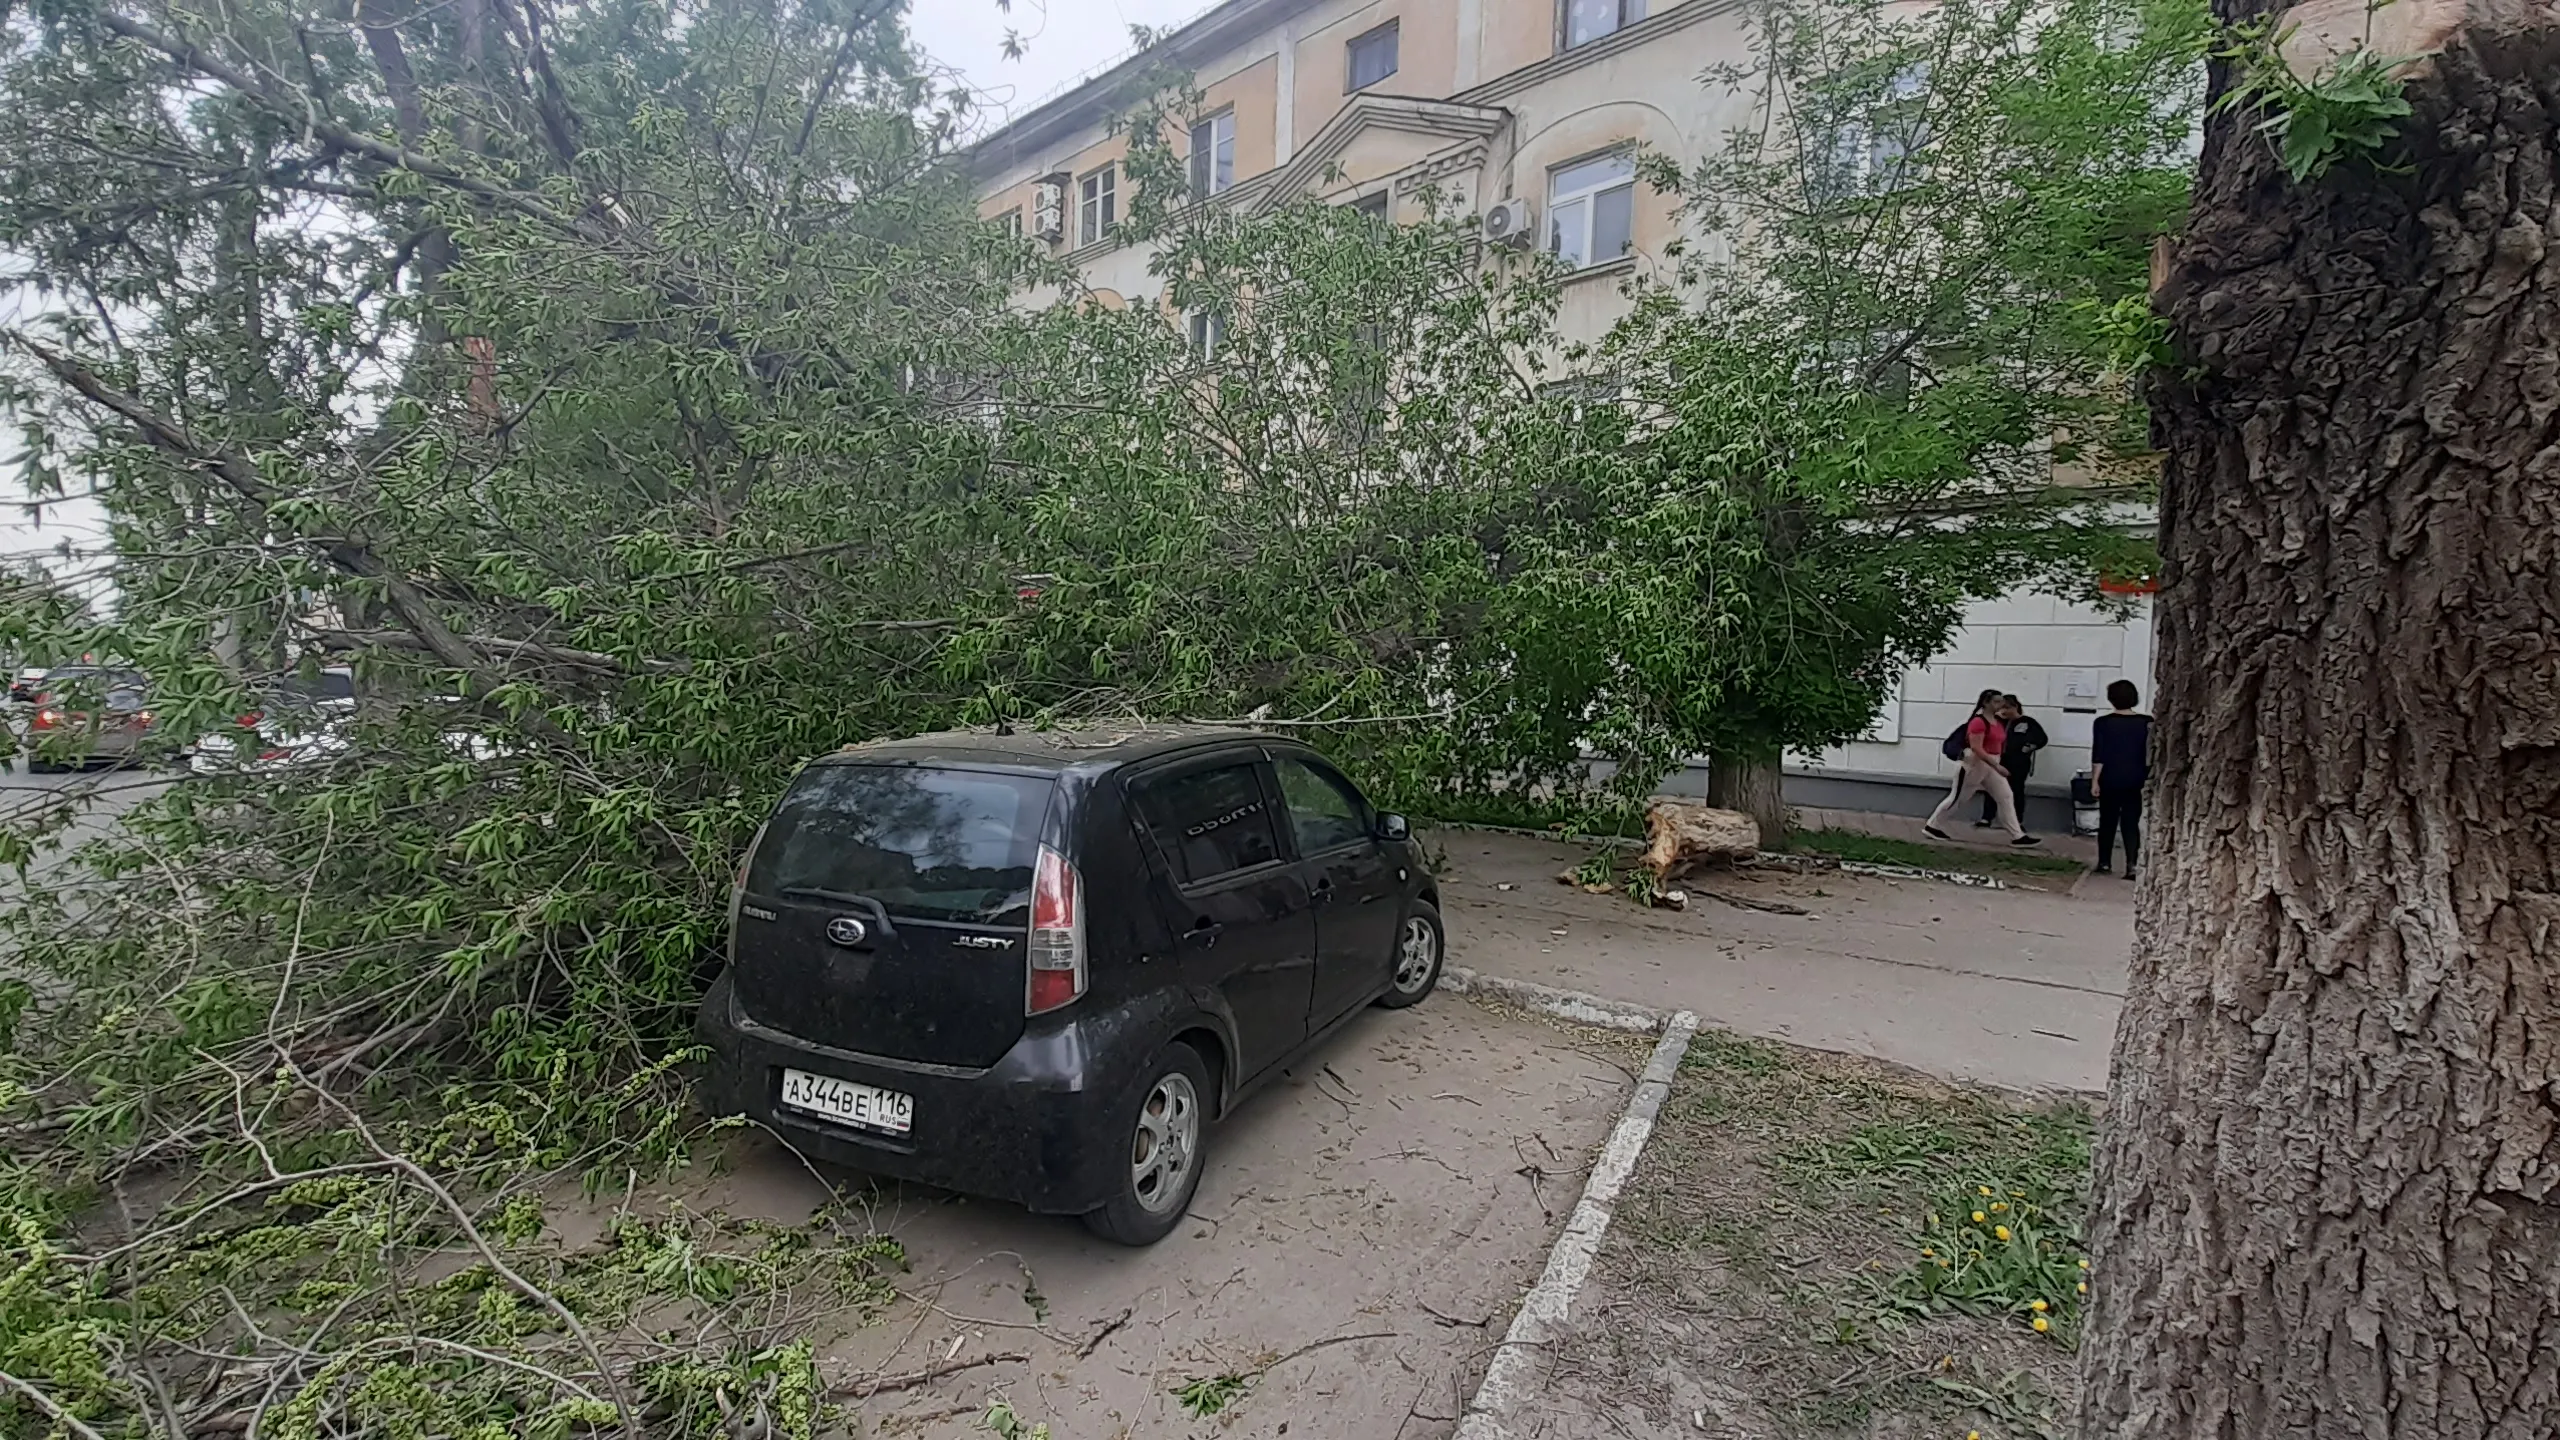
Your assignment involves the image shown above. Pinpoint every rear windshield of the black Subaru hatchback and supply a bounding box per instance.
[748,766,1050,925]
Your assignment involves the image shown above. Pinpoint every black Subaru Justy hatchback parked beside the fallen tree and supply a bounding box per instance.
[699,728,1444,1245]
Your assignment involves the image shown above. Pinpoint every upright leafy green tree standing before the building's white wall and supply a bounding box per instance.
[1533,0,2204,833]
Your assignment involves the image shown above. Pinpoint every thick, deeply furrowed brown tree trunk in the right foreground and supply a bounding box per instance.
[2079,14,2560,1440]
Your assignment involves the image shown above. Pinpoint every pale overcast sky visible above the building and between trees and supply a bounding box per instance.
[0,0,1213,584]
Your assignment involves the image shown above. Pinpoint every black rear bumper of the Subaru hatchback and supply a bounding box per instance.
[696,971,1119,1215]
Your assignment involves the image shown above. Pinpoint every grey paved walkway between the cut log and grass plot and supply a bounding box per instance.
[1431,830,2132,1092]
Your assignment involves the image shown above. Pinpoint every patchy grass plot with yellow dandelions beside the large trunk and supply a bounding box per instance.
[1531,1033,2089,1440]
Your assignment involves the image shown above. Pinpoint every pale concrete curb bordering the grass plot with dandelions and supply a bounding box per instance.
[1441,994,1697,1440]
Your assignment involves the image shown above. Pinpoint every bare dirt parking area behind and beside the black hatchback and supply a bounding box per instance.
[558,994,1649,1440]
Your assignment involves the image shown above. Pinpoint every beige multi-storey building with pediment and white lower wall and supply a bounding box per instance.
[975,0,2150,825]
